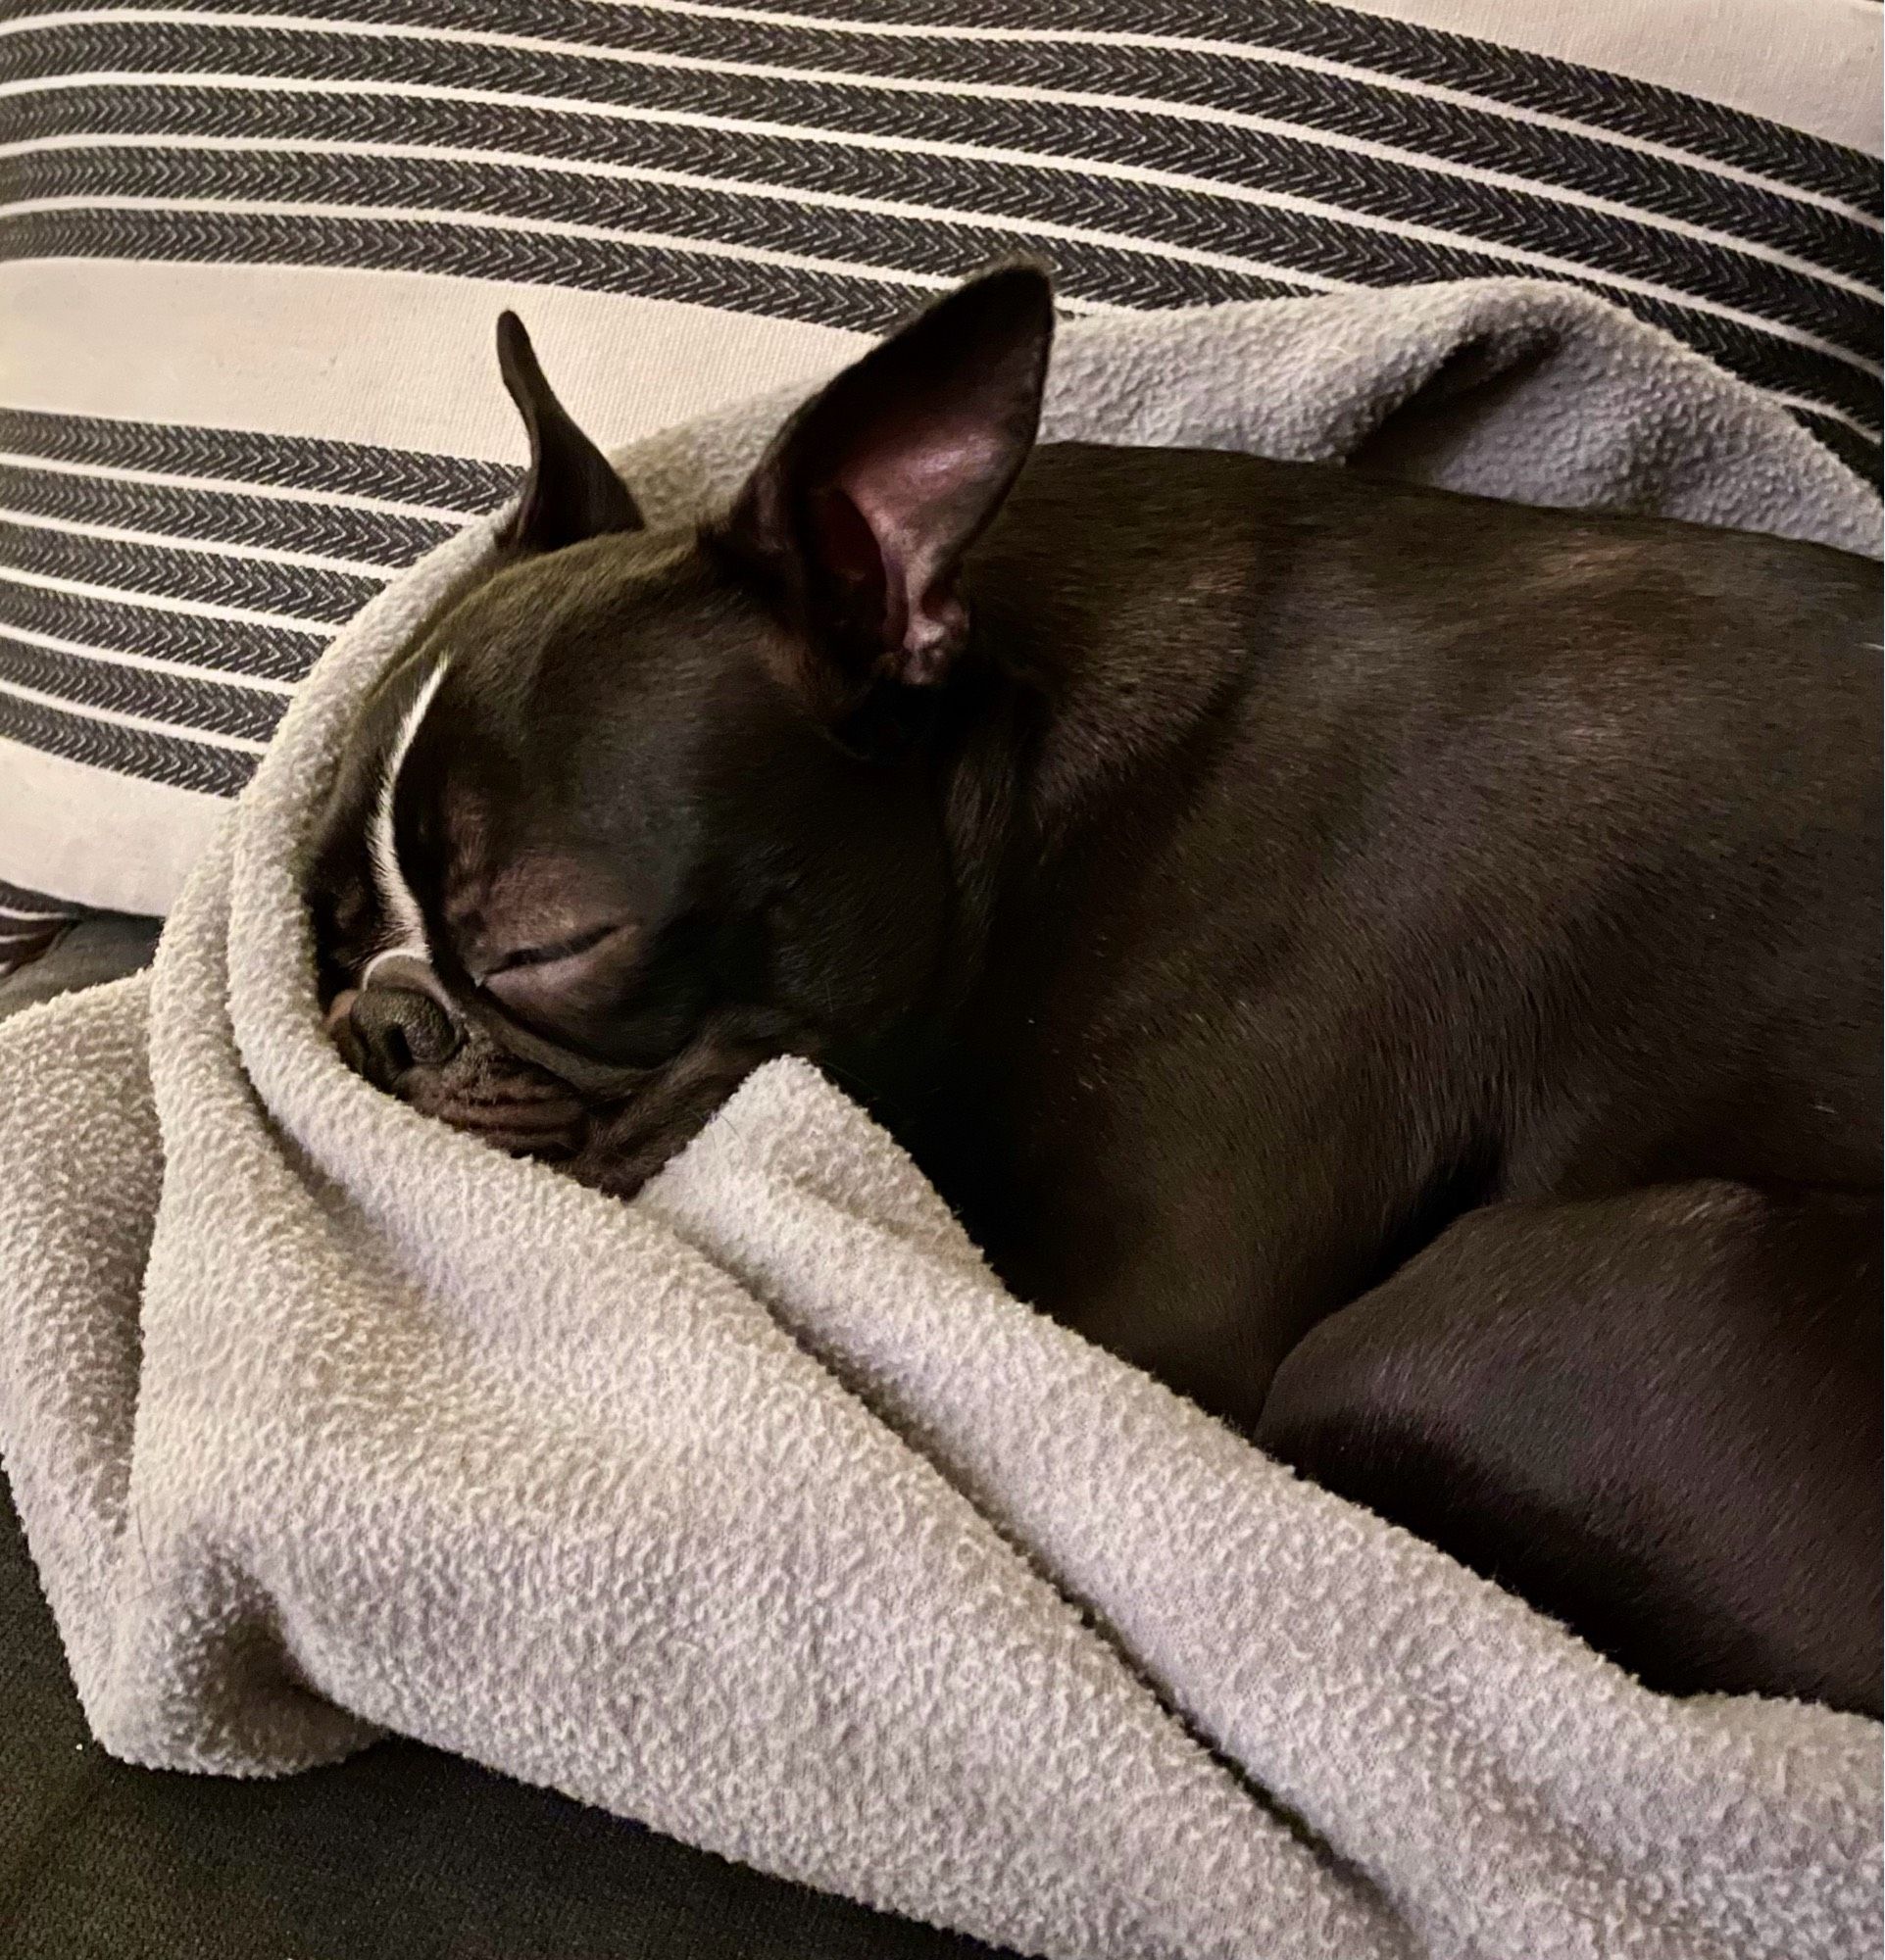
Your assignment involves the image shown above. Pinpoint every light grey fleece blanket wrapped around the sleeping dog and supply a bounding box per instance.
[0,282,1879,1960]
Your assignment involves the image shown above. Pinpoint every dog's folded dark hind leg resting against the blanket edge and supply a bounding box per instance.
[1256,1184,1881,1715]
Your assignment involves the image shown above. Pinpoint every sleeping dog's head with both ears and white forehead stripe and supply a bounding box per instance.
[310,269,1052,1190]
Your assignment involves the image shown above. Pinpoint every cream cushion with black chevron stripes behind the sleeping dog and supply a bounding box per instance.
[0,0,1881,941]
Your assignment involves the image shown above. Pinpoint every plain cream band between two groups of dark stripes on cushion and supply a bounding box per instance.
[0,259,870,463]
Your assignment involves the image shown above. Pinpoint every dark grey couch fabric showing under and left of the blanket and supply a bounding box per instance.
[0,919,989,1960]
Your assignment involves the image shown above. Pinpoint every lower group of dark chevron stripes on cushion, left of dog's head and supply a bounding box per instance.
[0,410,516,800]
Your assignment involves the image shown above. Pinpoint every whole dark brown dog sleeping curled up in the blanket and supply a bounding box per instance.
[301,267,1881,1713]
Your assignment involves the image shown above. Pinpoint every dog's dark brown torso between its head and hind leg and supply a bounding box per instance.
[909,447,1879,1325]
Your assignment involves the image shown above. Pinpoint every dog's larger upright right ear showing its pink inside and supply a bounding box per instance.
[719,265,1054,713]
